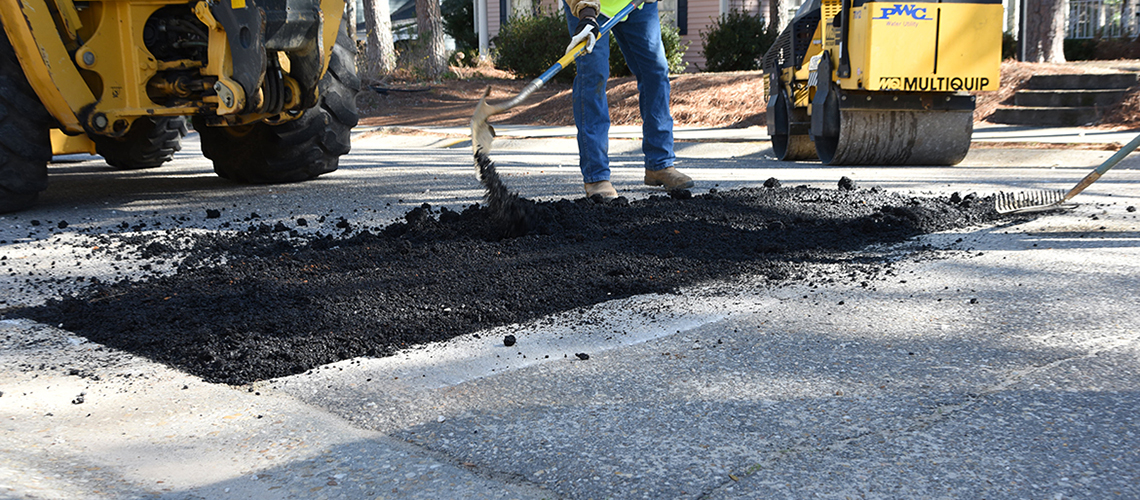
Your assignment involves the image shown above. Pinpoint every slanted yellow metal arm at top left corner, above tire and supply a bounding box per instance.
[0,0,95,132]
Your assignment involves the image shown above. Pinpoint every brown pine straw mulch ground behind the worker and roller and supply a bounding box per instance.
[358,60,1140,129]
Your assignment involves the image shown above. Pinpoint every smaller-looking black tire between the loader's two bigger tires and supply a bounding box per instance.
[95,116,189,170]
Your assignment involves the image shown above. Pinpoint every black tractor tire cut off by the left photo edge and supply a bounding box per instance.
[0,22,54,213]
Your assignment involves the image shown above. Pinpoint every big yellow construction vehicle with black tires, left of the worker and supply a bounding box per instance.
[0,0,360,213]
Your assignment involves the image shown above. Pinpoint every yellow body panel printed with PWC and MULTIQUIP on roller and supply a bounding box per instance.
[840,2,1002,92]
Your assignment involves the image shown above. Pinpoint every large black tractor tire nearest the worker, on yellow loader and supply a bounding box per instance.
[194,9,360,183]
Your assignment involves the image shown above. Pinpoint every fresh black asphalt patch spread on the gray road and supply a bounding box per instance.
[15,164,996,384]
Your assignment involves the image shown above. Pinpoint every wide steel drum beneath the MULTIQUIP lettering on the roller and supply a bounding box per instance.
[815,109,974,165]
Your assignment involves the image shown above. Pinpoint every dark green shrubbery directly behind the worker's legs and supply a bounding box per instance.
[495,10,689,82]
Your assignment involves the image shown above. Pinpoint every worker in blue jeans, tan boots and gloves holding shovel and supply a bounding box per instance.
[562,0,693,200]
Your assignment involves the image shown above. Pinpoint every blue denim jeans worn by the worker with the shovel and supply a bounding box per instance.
[562,2,676,183]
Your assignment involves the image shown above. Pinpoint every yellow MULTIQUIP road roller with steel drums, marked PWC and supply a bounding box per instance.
[764,0,1002,165]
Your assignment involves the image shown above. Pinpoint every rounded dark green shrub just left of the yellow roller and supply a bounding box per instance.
[701,10,779,72]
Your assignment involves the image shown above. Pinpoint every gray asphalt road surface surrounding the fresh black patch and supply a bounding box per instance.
[0,126,1140,499]
